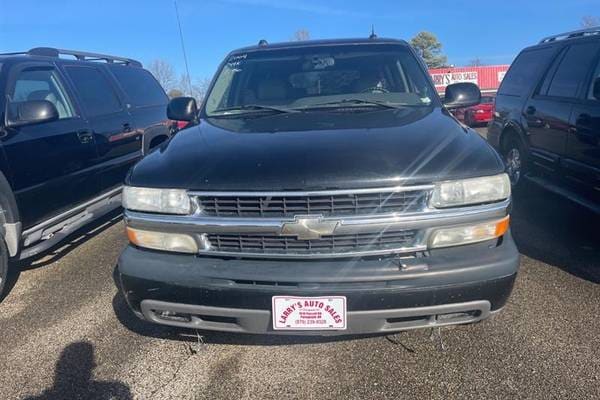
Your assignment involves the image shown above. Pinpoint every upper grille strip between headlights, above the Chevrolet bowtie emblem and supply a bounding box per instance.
[197,189,429,218]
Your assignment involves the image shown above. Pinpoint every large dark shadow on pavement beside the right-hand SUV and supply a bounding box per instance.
[511,182,600,283]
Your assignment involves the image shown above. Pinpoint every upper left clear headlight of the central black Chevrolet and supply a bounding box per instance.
[123,186,191,214]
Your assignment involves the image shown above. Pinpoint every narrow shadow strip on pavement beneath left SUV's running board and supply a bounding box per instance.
[0,210,122,303]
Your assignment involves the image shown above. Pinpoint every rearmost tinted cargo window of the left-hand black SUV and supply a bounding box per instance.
[111,65,168,107]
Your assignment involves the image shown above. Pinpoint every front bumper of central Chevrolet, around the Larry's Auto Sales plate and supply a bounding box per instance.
[118,233,519,335]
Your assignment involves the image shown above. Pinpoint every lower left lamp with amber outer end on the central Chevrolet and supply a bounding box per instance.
[127,227,198,254]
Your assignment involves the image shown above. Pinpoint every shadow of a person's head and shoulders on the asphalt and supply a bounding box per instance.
[27,342,132,400]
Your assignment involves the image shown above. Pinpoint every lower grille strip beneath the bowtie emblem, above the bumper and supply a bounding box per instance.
[208,230,418,255]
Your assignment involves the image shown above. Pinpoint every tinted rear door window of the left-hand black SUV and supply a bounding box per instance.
[65,66,122,117]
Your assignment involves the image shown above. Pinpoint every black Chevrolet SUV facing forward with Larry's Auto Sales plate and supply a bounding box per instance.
[118,38,519,335]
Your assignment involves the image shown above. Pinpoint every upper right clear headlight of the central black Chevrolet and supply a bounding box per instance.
[431,174,510,208]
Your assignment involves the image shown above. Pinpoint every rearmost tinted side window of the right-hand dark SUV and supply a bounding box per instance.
[498,47,554,96]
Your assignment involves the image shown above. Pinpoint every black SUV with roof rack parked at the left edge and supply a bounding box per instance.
[0,48,169,293]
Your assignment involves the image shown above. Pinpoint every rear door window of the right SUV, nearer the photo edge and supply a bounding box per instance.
[540,43,597,98]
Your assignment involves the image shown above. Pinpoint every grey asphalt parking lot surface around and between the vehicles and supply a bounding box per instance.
[0,129,600,399]
